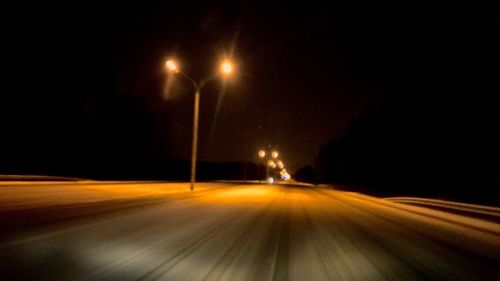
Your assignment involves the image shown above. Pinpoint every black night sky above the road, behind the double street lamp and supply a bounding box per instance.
[0,1,497,174]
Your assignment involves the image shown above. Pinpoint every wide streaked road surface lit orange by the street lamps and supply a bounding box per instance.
[0,183,500,281]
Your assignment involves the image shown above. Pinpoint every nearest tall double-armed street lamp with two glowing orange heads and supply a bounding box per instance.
[165,58,234,191]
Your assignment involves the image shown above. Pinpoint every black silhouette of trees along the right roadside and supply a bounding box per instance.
[308,99,500,205]
